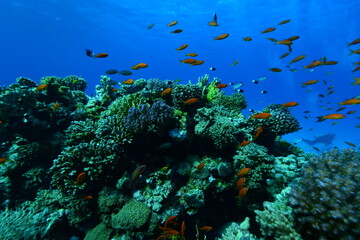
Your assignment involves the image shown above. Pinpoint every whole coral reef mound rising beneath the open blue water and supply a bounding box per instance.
[0,74,360,240]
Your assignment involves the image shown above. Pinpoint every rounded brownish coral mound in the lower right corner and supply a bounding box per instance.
[289,149,360,240]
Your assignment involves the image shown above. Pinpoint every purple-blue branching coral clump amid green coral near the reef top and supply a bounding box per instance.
[122,101,175,135]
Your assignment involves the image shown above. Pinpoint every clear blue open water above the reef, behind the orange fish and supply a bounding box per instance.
[0,0,360,151]
